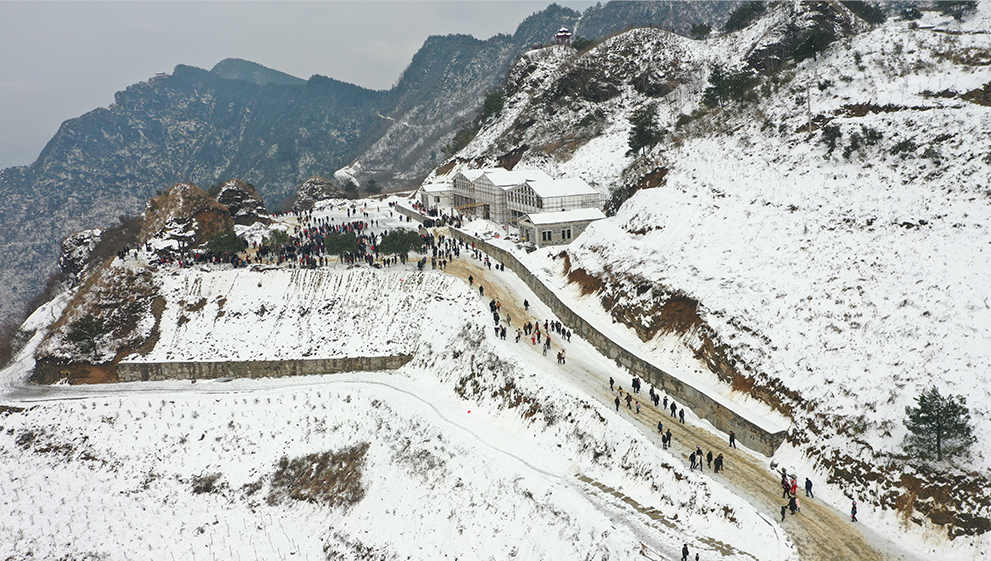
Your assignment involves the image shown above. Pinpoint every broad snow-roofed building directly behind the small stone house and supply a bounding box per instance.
[507,177,603,224]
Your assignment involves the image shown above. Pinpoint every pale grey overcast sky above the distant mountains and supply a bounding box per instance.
[0,0,594,168]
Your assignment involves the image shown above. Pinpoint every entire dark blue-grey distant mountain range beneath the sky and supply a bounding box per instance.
[0,2,737,328]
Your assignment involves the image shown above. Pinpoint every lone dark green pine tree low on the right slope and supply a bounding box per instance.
[905,386,976,461]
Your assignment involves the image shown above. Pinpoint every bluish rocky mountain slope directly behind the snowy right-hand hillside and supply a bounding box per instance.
[342,2,736,186]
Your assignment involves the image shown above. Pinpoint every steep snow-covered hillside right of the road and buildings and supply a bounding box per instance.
[441,2,991,558]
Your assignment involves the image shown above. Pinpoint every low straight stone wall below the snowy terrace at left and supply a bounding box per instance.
[117,355,413,382]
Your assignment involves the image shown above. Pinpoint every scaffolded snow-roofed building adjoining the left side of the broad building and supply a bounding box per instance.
[453,168,550,224]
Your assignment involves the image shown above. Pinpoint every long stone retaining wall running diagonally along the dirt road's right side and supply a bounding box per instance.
[449,228,785,456]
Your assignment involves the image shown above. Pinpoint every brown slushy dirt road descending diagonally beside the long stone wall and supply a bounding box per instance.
[445,250,888,561]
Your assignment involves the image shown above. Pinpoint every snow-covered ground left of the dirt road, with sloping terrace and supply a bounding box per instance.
[0,199,795,559]
